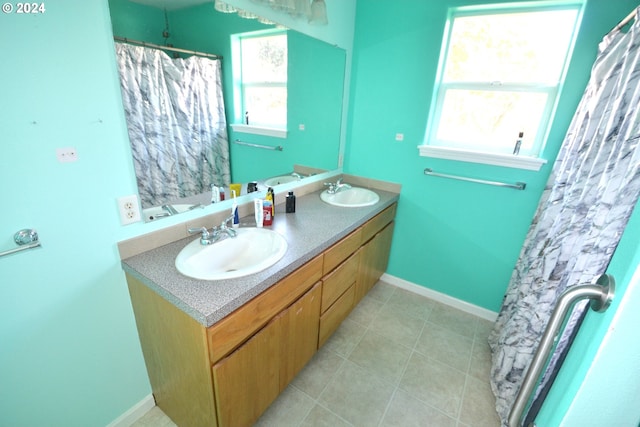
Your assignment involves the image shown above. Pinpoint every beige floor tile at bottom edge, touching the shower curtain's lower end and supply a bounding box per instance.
[460,377,500,427]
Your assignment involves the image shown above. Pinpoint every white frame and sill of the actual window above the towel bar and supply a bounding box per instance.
[418,0,584,171]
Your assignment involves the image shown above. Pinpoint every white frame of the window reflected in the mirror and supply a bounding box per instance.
[231,29,288,138]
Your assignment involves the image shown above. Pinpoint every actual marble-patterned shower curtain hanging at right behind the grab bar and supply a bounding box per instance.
[489,8,640,425]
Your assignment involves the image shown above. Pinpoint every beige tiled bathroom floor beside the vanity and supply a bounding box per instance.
[134,282,500,427]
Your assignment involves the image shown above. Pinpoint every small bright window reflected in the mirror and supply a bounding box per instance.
[234,31,287,129]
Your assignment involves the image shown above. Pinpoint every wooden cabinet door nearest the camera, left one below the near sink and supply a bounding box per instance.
[212,317,281,427]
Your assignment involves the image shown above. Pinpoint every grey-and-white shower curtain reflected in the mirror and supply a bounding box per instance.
[116,42,231,207]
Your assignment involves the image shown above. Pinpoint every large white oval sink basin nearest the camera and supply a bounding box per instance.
[176,227,287,280]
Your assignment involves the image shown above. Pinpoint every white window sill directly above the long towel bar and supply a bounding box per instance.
[418,145,547,171]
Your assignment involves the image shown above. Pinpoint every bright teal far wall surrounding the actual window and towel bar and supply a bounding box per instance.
[344,0,637,311]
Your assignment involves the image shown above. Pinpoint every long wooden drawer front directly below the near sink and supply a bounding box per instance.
[207,255,322,363]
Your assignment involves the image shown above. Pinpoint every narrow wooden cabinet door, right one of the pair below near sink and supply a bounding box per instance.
[279,282,322,391]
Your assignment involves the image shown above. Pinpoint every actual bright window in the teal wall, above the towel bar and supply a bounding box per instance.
[421,2,582,168]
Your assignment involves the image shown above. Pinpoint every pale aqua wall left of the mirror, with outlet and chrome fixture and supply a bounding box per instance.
[0,0,151,427]
